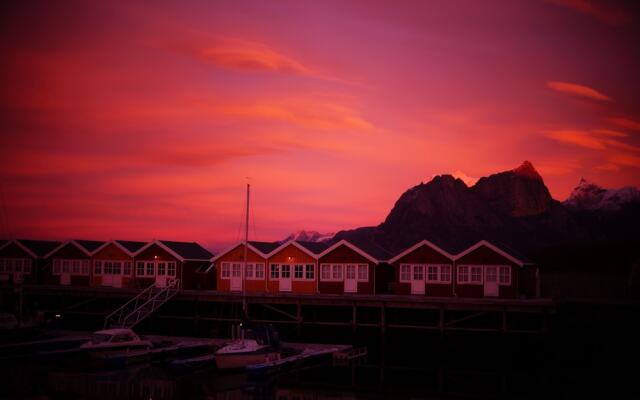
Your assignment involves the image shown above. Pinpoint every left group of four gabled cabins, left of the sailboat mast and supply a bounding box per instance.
[0,240,215,289]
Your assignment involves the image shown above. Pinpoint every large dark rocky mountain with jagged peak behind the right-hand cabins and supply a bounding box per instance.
[331,161,640,253]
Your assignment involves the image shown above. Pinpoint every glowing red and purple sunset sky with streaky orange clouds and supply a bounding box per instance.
[0,0,640,250]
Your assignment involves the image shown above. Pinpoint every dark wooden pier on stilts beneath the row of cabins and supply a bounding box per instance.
[6,285,556,338]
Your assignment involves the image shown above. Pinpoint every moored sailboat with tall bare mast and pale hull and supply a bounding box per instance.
[215,184,280,369]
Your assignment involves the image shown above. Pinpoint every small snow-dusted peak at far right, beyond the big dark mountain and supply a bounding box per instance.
[563,178,640,211]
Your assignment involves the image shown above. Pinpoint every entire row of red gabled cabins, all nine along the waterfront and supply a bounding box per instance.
[0,236,539,298]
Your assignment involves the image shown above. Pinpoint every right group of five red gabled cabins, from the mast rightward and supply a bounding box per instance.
[212,240,539,298]
